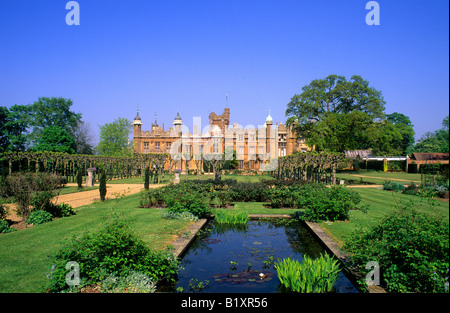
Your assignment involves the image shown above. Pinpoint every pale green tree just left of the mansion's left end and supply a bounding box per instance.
[97,117,133,156]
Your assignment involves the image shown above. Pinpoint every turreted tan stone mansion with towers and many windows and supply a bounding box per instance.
[133,108,311,170]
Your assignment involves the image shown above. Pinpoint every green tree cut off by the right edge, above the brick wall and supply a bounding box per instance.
[414,115,449,153]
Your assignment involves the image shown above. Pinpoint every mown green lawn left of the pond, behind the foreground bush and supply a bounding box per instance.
[0,194,187,292]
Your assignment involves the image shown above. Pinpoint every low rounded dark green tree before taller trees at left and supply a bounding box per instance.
[33,126,76,154]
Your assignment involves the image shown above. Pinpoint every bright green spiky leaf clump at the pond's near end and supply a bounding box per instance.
[274,254,340,293]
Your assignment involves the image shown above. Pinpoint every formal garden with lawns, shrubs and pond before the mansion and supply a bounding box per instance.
[0,152,449,293]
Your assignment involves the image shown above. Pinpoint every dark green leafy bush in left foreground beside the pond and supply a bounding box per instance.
[49,214,178,292]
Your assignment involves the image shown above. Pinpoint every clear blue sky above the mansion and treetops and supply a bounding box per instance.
[0,0,449,145]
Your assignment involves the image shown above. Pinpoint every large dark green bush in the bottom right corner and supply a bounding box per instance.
[344,203,449,292]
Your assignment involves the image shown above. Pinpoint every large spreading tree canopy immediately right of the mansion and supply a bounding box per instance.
[286,75,414,155]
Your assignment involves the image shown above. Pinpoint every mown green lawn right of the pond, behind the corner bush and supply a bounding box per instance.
[320,188,449,243]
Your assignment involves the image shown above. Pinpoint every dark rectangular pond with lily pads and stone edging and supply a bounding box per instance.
[158,219,358,293]
